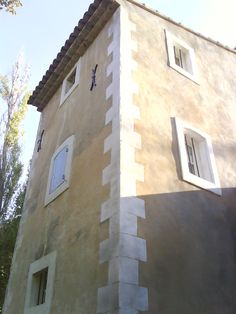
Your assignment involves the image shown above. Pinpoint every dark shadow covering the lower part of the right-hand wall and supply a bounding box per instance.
[138,188,236,314]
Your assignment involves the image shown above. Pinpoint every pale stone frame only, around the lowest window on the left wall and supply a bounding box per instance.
[24,251,57,314]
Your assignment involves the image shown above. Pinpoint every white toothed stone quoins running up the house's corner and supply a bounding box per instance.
[97,6,148,314]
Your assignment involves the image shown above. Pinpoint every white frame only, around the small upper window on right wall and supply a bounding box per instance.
[165,30,198,83]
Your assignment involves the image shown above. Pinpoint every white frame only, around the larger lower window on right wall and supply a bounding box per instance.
[175,118,222,195]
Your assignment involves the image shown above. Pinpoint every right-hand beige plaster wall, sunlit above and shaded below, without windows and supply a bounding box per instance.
[129,4,236,314]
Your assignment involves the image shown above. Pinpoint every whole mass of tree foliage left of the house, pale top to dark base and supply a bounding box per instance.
[0,57,29,313]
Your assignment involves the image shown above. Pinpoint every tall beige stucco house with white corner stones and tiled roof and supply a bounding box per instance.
[4,0,236,314]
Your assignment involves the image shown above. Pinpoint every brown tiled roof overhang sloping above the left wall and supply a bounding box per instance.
[28,0,119,112]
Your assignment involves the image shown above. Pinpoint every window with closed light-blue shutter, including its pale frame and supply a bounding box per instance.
[45,135,74,205]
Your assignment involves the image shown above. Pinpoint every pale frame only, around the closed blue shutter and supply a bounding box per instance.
[44,135,74,206]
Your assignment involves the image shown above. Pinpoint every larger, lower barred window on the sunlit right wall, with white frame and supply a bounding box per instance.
[175,118,221,195]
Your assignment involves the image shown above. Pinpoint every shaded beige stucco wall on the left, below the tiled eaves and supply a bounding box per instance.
[3,13,111,314]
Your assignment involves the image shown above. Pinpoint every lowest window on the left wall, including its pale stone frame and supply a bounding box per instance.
[24,252,56,314]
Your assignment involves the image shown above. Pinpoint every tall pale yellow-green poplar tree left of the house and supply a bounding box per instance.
[0,57,29,221]
